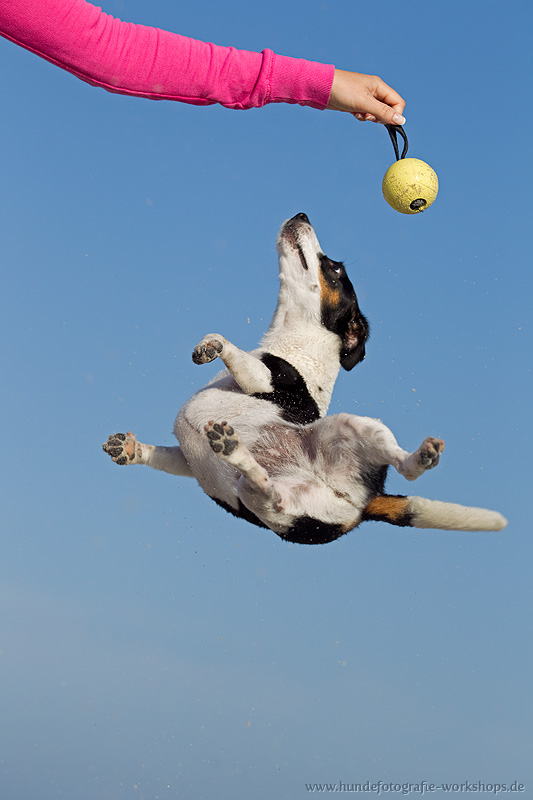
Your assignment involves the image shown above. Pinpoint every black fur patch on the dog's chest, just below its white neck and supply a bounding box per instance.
[252,353,320,425]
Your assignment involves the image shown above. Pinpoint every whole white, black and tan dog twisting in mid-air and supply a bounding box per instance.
[103,214,507,544]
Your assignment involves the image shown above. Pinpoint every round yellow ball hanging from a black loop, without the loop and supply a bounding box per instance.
[382,158,439,214]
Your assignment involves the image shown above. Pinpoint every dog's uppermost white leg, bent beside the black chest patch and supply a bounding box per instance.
[192,333,273,394]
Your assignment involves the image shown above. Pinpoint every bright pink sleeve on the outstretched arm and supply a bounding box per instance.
[0,0,334,109]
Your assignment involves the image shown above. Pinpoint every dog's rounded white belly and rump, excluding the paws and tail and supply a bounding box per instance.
[170,377,386,541]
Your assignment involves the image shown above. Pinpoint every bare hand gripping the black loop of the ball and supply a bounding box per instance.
[326,69,405,125]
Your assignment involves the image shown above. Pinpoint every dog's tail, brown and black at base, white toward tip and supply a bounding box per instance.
[362,494,507,531]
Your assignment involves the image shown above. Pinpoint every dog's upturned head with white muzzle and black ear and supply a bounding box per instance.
[278,214,369,370]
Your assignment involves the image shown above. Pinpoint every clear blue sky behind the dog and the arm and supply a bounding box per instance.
[0,0,533,800]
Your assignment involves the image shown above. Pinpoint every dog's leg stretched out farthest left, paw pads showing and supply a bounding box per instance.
[102,431,193,478]
